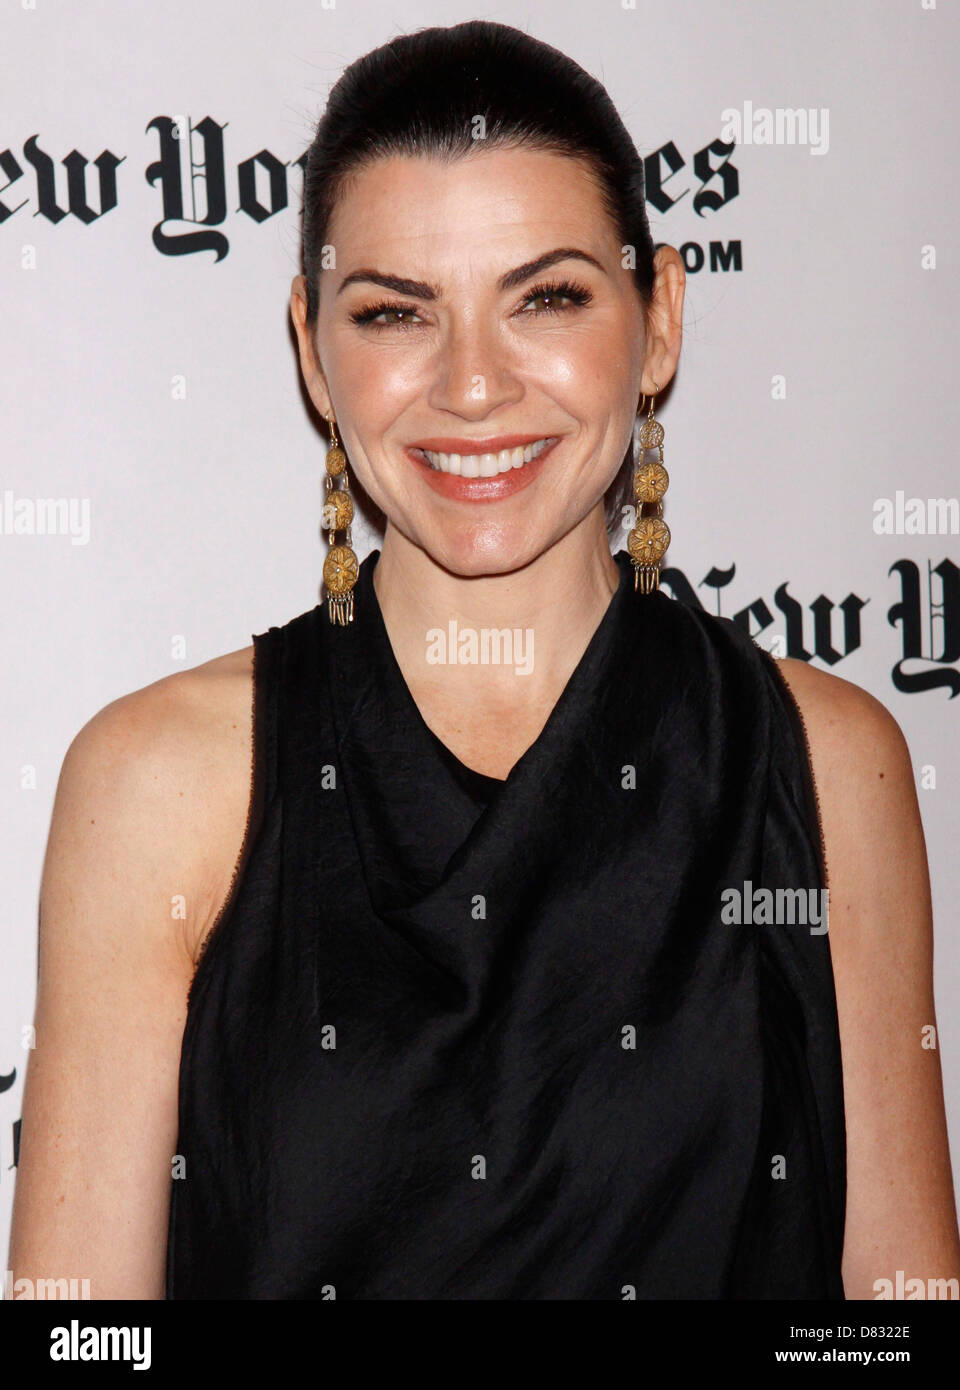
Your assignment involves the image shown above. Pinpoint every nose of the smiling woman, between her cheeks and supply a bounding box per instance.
[428,317,524,420]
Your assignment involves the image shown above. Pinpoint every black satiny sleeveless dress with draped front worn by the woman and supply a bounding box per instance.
[167,550,845,1300]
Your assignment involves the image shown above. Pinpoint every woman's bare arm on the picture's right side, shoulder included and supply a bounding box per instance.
[778,659,960,1298]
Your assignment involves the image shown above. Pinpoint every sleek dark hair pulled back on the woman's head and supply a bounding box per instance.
[301,19,654,534]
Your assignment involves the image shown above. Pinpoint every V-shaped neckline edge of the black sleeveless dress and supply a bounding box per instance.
[357,549,632,803]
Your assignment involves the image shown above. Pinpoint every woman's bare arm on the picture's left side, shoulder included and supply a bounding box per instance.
[10,656,249,1298]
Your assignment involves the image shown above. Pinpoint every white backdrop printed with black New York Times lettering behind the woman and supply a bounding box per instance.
[0,0,960,1252]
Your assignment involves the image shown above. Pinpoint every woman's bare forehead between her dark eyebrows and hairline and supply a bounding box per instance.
[326,142,617,281]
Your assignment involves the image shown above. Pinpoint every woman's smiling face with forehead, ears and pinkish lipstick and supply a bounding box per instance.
[292,149,682,575]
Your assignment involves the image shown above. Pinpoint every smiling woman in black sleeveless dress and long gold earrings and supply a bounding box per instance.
[13,22,960,1298]
